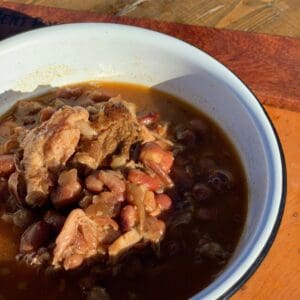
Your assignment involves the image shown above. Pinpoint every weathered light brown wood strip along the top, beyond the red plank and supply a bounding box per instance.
[8,0,300,37]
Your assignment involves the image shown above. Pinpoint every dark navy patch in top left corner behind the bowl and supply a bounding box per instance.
[0,6,47,40]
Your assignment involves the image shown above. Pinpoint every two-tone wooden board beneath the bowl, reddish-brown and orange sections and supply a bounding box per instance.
[0,0,300,300]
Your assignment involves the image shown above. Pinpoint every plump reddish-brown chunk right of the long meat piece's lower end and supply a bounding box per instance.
[51,169,82,207]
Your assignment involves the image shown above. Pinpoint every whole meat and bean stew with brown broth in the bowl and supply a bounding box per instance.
[0,83,247,300]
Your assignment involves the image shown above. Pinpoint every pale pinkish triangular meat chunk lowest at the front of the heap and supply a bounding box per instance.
[52,209,118,270]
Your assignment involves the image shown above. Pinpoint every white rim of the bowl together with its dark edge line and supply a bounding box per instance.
[0,22,287,299]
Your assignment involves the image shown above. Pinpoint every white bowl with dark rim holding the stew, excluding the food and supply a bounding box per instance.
[0,24,286,299]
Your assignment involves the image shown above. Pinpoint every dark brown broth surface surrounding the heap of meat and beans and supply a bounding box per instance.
[0,83,247,300]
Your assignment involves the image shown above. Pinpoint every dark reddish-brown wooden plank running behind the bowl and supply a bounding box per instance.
[0,1,300,111]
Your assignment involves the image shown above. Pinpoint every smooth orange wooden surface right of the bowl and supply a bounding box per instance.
[233,106,300,300]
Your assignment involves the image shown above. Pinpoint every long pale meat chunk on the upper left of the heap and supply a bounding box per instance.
[21,106,89,206]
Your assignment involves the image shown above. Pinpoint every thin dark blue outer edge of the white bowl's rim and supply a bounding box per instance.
[1,22,287,299]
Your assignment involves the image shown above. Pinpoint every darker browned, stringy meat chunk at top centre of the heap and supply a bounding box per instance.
[74,98,139,169]
